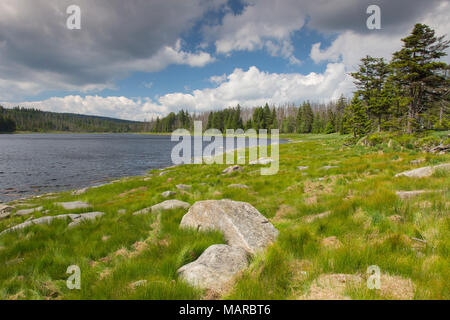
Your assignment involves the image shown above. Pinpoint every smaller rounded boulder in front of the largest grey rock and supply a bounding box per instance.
[177,244,248,291]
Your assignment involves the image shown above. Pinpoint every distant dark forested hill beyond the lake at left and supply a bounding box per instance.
[0,106,146,132]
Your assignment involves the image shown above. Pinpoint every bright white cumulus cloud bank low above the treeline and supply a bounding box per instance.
[4,63,351,121]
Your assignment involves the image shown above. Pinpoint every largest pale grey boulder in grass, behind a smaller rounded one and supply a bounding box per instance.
[180,200,278,254]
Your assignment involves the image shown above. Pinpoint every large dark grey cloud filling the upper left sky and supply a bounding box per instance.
[0,0,224,99]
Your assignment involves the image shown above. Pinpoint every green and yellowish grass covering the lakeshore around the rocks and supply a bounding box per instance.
[0,134,450,299]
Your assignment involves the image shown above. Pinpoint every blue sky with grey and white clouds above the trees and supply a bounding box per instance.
[0,0,450,121]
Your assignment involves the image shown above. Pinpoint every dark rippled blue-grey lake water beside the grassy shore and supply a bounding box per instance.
[0,134,286,202]
